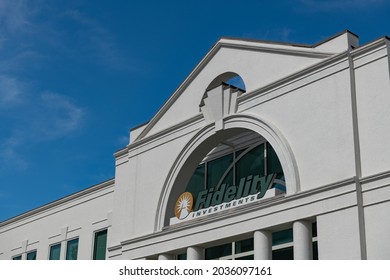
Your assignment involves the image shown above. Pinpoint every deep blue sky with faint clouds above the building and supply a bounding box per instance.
[0,0,390,221]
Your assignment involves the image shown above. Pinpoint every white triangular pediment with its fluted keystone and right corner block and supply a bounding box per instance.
[132,32,357,142]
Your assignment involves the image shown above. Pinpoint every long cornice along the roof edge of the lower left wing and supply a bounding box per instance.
[0,178,115,228]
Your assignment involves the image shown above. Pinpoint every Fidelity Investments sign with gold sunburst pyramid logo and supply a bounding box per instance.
[170,174,284,225]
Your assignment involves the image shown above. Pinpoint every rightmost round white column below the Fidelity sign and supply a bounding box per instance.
[293,221,313,260]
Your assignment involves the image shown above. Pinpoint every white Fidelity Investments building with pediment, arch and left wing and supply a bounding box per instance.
[0,31,390,260]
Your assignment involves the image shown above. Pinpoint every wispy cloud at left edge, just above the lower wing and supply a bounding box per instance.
[0,88,85,169]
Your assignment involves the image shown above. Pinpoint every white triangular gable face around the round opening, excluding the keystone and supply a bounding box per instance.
[135,35,348,141]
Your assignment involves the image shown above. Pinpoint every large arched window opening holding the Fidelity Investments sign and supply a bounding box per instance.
[172,132,286,223]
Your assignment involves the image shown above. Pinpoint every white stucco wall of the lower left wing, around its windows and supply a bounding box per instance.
[0,182,114,260]
